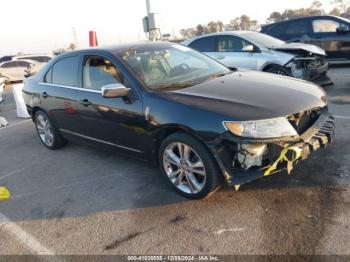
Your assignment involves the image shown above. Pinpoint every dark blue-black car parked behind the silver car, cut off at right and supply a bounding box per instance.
[261,16,350,62]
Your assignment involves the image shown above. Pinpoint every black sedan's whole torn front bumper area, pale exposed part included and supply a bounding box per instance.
[208,111,335,187]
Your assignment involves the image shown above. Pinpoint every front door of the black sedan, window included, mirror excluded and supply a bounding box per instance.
[77,53,146,154]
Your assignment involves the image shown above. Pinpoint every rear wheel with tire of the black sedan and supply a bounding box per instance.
[34,110,66,149]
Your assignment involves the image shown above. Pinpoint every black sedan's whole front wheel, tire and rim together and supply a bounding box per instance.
[159,132,221,199]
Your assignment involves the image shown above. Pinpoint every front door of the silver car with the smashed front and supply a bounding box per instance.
[212,35,260,70]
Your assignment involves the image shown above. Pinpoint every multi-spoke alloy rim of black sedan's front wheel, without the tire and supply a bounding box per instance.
[163,142,206,194]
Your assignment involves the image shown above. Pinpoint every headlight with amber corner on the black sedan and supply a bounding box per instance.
[223,117,298,138]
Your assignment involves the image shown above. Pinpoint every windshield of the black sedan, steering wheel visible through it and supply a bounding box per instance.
[120,44,231,90]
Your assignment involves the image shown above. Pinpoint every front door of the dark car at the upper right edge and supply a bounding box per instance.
[311,18,350,60]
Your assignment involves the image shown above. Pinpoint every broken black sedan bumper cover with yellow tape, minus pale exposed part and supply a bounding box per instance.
[209,112,335,186]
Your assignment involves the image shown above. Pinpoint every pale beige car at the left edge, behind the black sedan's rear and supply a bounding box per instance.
[0,60,40,82]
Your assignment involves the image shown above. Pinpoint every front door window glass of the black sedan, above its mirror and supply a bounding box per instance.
[83,56,123,91]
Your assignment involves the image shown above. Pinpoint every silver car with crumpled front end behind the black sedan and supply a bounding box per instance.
[182,31,332,86]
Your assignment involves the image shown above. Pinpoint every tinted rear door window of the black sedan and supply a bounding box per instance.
[52,56,79,87]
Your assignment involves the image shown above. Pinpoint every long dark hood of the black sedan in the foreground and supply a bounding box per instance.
[162,71,326,121]
